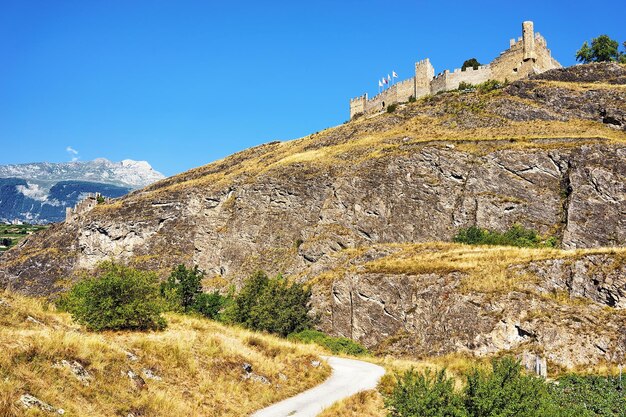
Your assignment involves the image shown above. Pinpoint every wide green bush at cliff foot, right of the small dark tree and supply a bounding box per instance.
[224,271,314,337]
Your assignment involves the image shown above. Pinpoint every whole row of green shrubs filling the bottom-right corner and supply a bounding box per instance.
[381,357,626,417]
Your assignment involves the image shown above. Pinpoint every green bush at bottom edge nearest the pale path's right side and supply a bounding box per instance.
[385,369,467,417]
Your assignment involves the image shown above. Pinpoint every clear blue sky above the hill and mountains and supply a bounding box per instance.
[0,0,626,175]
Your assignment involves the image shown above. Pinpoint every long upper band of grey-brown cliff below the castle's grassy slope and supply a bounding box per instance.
[3,140,626,293]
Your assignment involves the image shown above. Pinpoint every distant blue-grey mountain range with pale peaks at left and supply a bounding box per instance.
[0,158,164,224]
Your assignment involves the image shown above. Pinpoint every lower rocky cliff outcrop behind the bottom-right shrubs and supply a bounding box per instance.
[308,245,626,367]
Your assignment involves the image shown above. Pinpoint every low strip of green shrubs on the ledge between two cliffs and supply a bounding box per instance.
[453,224,558,248]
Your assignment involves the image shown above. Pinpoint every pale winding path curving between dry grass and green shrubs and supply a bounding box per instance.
[251,356,385,417]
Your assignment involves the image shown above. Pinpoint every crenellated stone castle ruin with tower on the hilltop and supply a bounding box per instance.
[350,21,561,119]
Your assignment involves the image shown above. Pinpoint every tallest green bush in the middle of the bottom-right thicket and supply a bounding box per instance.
[465,357,554,417]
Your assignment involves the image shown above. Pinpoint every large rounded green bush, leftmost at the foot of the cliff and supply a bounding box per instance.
[58,262,165,331]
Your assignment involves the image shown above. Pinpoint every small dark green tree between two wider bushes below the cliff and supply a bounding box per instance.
[161,264,204,312]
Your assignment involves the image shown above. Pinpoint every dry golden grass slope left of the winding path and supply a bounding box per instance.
[0,293,329,416]
